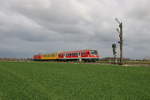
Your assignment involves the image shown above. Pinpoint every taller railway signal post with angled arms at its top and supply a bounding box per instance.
[115,18,123,65]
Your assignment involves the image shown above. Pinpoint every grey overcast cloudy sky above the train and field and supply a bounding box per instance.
[0,0,150,58]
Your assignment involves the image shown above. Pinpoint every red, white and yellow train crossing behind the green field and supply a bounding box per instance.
[33,49,100,62]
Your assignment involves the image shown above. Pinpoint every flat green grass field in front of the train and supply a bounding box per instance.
[0,62,150,100]
